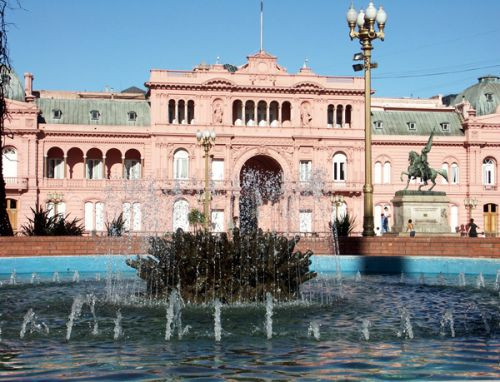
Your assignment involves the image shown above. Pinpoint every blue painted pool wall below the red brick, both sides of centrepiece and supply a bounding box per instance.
[0,255,500,275]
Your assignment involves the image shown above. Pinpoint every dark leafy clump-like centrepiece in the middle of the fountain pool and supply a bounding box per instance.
[127,229,316,303]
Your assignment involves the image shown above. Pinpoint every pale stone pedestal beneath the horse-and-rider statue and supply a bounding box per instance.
[392,190,451,234]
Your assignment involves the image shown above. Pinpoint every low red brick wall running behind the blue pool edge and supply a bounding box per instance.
[0,236,500,258]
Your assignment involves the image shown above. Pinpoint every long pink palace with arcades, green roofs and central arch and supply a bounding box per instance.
[2,52,500,234]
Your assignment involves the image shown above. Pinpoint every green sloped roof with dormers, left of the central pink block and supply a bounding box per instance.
[36,98,151,126]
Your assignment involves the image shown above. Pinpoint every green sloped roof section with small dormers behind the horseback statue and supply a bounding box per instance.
[372,110,464,136]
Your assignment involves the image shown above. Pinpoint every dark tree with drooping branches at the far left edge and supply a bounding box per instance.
[0,0,14,236]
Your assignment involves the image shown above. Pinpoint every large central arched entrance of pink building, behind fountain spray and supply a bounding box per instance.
[240,155,283,232]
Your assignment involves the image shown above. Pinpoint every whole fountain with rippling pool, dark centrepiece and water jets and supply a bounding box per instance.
[0,176,500,380]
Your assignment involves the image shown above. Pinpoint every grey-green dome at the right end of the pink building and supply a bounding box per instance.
[451,75,500,115]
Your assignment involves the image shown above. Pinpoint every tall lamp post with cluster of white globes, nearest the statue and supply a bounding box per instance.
[347,1,387,236]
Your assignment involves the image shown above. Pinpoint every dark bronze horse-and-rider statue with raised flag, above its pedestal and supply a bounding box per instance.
[401,130,448,191]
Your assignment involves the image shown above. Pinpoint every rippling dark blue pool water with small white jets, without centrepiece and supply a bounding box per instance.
[0,260,500,380]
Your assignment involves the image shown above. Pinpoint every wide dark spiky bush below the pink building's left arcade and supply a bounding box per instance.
[21,207,84,236]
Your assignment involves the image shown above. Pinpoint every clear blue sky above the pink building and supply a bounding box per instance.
[7,0,500,97]
